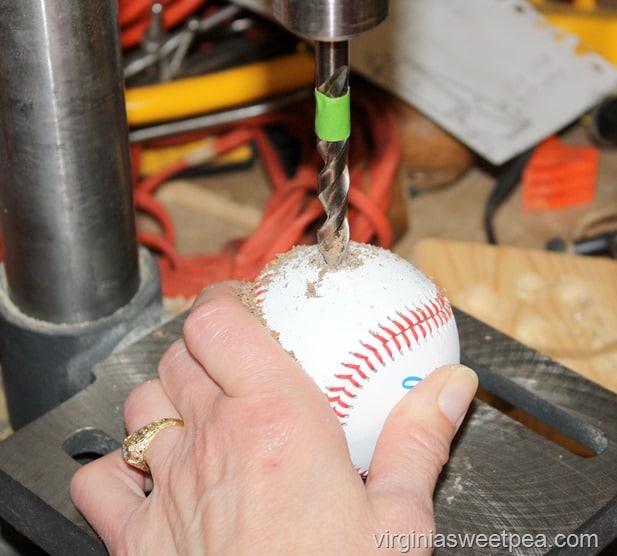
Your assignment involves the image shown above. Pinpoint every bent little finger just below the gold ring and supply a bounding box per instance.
[70,450,146,554]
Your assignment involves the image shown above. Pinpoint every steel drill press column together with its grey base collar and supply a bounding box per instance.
[0,0,162,429]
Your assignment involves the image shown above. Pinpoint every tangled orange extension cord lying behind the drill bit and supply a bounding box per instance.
[132,93,400,298]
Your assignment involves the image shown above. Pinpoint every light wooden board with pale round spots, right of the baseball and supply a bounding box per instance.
[410,239,617,392]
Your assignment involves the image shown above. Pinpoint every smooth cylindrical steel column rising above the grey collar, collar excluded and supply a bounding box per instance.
[0,0,139,323]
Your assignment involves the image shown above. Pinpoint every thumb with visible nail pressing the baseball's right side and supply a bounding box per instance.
[366,365,478,513]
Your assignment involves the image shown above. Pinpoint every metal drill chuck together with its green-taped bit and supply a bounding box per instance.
[272,0,388,267]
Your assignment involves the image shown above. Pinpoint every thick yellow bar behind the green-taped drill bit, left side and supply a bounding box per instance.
[126,52,315,126]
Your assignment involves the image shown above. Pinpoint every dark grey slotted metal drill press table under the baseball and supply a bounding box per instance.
[0,304,617,555]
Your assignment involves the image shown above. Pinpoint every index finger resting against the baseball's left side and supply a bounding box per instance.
[184,282,319,396]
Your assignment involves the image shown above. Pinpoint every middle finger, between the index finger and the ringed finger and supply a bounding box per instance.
[159,340,222,420]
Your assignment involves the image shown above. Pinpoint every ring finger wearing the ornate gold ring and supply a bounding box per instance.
[124,380,182,481]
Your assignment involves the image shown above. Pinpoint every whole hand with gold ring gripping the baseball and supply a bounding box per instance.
[71,283,477,556]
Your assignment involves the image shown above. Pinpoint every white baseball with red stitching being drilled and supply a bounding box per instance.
[253,242,460,474]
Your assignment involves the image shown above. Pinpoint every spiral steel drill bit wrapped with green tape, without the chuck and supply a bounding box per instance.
[315,41,349,267]
